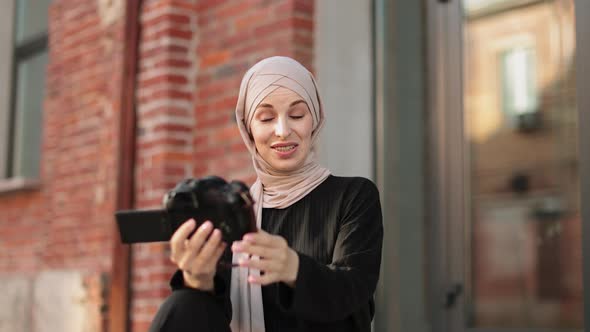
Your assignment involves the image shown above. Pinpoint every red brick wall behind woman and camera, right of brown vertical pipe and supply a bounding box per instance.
[132,0,313,331]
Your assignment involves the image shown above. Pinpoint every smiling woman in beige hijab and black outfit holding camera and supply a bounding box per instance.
[150,57,383,332]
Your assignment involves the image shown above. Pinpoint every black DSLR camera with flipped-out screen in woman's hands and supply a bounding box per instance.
[115,176,256,244]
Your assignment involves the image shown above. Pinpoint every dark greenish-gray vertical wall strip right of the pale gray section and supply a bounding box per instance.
[375,0,432,332]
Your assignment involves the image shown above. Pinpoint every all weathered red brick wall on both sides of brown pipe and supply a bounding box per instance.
[0,0,314,331]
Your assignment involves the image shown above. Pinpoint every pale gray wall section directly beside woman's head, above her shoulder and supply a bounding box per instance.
[315,0,374,179]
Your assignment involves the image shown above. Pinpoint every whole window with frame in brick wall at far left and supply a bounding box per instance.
[0,0,51,181]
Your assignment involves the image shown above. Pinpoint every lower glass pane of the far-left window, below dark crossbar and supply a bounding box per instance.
[12,52,47,178]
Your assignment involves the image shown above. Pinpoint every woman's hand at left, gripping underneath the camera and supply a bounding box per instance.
[170,219,227,291]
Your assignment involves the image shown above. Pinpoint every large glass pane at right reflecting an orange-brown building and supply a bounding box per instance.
[463,0,584,331]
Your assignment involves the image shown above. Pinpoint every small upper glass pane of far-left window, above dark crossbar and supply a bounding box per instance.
[16,0,52,45]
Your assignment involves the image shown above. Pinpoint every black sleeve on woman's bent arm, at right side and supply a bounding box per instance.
[279,182,383,321]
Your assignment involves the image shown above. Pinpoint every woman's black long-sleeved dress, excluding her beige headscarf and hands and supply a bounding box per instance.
[150,176,383,332]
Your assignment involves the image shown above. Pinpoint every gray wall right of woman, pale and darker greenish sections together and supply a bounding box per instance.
[315,0,430,332]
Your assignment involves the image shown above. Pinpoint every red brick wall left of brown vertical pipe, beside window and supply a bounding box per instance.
[0,0,128,328]
